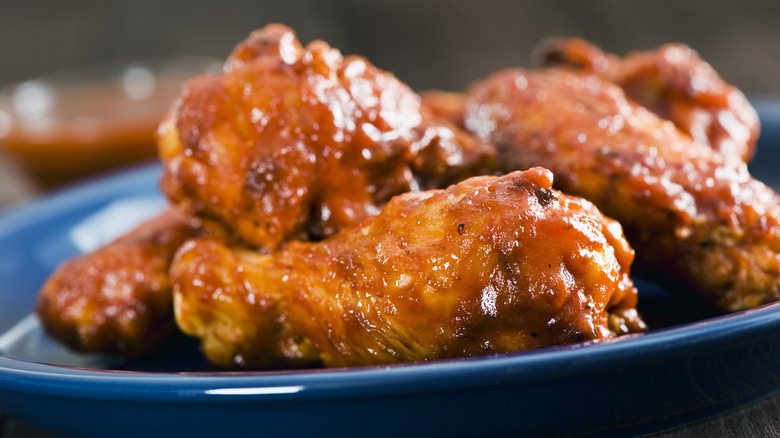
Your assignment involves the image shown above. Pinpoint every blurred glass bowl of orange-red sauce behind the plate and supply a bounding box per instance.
[0,57,221,188]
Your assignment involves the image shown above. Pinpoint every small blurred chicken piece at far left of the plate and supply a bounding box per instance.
[36,209,203,357]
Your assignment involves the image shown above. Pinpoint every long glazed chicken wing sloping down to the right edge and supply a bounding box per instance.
[464,69,780,311]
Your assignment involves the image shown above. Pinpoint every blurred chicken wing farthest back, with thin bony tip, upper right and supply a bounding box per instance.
[537,38,760,161]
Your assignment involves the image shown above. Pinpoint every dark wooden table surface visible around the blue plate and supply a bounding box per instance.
[0,153,780,438]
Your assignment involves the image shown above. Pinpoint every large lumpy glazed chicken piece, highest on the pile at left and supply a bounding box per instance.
[159,25,494,250]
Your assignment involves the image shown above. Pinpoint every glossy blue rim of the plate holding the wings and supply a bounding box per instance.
[0,163,780,401]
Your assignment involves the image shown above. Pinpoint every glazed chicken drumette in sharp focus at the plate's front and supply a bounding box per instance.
[171,168,644,368]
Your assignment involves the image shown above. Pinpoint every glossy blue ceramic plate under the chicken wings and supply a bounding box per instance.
[0,101,780,437]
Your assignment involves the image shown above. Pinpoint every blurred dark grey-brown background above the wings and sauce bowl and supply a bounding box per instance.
[0,0,780,206]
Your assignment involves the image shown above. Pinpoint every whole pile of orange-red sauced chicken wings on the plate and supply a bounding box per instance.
[36,24,780,369]
